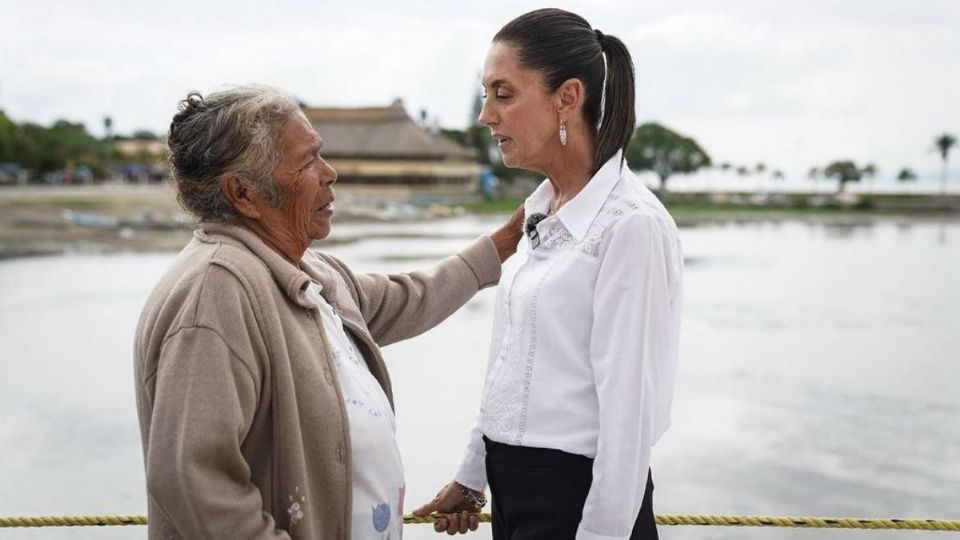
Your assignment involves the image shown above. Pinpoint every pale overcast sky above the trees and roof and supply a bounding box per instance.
[0,0,960,180]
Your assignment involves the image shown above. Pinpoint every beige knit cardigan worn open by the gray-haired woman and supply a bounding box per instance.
[134,224,500,540]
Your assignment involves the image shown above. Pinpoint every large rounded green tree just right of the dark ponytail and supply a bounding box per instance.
[626,123,710,191]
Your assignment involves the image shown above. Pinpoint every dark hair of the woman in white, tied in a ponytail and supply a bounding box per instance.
[493,8,636,172]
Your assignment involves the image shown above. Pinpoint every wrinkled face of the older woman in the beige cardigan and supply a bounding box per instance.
[260,111,337,246]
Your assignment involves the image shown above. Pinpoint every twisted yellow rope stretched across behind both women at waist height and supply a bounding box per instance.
[0,514,960,532]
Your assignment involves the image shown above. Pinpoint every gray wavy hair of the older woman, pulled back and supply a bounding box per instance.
[167,86,299,221]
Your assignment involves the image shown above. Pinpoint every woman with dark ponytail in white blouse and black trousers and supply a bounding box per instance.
[414,9,683,540]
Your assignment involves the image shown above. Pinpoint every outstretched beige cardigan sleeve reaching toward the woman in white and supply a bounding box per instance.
[346,236,500,346]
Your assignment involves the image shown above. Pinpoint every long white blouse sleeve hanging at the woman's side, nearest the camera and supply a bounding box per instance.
[576,214,679,540]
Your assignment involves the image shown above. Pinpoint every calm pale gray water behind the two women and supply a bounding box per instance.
[0,214,960,540]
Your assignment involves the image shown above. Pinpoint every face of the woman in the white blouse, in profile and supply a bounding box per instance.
[478,42,560,172]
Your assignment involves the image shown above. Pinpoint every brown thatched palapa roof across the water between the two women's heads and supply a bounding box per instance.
[303,100,477,161]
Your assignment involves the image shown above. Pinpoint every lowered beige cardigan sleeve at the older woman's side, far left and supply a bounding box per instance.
[146,326,290,540]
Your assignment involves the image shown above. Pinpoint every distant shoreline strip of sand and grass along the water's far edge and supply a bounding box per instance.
[0,185,960,260]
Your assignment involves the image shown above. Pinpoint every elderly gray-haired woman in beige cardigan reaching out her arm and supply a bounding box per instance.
[134,87,521,540]
